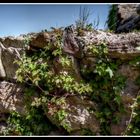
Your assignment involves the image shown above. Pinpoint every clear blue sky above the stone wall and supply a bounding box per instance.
[0,4,109,37]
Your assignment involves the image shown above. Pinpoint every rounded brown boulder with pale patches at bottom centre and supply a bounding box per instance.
[46,96,99,134]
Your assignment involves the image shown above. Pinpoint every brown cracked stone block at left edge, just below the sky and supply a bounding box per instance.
[0,37,24,80]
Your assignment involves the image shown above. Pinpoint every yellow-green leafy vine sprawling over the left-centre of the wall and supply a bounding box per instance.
[8,34,92,134]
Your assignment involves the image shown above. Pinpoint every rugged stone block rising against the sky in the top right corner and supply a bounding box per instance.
[116,4,140,33]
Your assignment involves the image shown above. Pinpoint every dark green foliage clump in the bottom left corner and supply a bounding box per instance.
[3,107,55,136]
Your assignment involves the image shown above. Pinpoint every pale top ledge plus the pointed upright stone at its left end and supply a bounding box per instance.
[63,28,140,60]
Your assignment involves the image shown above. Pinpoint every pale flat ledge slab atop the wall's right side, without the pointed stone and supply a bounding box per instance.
[81,31,140,60]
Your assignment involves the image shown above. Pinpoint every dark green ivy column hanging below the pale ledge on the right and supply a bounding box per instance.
[83,43,125,135]
